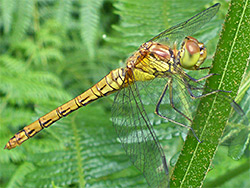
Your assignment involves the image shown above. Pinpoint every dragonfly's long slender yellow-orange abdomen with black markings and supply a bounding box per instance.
[5,68,126,149]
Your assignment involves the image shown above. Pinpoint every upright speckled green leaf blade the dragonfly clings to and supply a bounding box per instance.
[171,0,250,187]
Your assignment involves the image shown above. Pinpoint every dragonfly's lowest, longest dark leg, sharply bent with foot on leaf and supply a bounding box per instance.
[155,79,202,143]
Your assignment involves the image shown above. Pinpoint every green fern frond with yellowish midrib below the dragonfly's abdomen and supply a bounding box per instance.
[20,107,145,187]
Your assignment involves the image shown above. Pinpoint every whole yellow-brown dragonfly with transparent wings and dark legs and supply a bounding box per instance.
[5,3,234,187]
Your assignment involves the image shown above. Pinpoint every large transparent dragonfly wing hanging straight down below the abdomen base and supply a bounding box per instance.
[112,79,168,187]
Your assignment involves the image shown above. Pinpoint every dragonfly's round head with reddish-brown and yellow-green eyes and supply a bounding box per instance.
[179,36,207,70]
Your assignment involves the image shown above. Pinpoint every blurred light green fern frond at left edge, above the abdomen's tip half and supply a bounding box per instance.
[0,65,71,104]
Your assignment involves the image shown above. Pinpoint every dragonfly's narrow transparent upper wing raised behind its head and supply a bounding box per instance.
[149,3,220,45]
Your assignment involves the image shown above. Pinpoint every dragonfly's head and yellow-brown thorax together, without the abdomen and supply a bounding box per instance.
[127,36,207,81]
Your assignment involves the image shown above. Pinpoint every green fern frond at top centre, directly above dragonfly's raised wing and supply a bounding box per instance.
[107,0,222,54]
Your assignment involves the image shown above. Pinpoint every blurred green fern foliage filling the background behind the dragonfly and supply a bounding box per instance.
[0,0,250,188]
